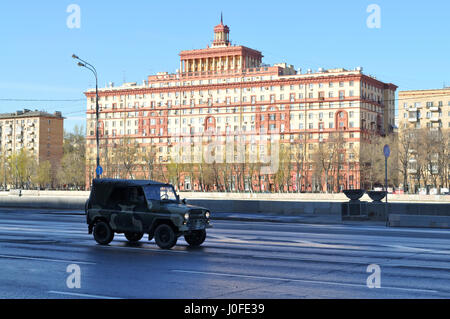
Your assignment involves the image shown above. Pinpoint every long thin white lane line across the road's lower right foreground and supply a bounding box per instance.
[172,269,438,293]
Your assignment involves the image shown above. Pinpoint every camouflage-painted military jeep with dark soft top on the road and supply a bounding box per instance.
[85,179,212,249]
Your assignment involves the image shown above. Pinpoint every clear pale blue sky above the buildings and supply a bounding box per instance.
[0,0,450,134]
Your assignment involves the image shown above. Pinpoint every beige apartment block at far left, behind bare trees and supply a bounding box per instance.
[0,109,64,185]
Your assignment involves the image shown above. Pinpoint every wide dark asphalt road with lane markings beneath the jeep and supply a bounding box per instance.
[0,209,450,299]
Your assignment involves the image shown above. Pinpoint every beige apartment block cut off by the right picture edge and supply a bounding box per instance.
[398,87,450,192]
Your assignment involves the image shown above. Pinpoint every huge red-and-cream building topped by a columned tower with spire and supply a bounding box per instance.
[85,17,397,191]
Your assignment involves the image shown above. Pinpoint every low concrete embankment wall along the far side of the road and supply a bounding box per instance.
[0,191,450,227]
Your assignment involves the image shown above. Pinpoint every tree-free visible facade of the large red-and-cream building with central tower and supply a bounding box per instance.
[85,18,397,191]
